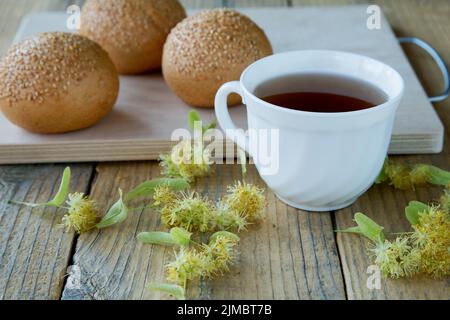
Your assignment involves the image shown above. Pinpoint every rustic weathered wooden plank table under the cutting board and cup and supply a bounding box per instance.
[0,0,450,300]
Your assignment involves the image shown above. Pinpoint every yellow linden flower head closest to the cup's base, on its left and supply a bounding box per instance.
[225,181,266,223]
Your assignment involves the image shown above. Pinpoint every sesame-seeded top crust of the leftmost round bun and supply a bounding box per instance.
[0,32,106,103]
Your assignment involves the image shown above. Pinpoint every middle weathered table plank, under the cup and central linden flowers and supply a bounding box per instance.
[63,162,345,299]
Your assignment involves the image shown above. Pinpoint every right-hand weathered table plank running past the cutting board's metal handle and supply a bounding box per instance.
[304,0,450,299]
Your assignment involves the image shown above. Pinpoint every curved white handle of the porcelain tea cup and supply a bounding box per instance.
[215,81,249,152]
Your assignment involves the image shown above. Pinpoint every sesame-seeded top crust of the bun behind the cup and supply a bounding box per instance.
[164,9,272,80]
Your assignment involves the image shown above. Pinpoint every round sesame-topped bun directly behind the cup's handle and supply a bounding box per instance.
[163,9,273,107]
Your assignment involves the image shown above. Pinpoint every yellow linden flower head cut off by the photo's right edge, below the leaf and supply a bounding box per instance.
[412,207,450,278]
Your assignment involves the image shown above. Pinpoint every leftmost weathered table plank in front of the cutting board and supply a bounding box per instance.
[0,164,92,300]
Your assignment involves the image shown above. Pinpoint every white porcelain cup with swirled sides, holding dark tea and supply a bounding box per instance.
[215,50,404,211]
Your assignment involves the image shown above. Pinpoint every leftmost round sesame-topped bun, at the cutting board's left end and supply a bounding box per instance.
[0,32,119,134]
